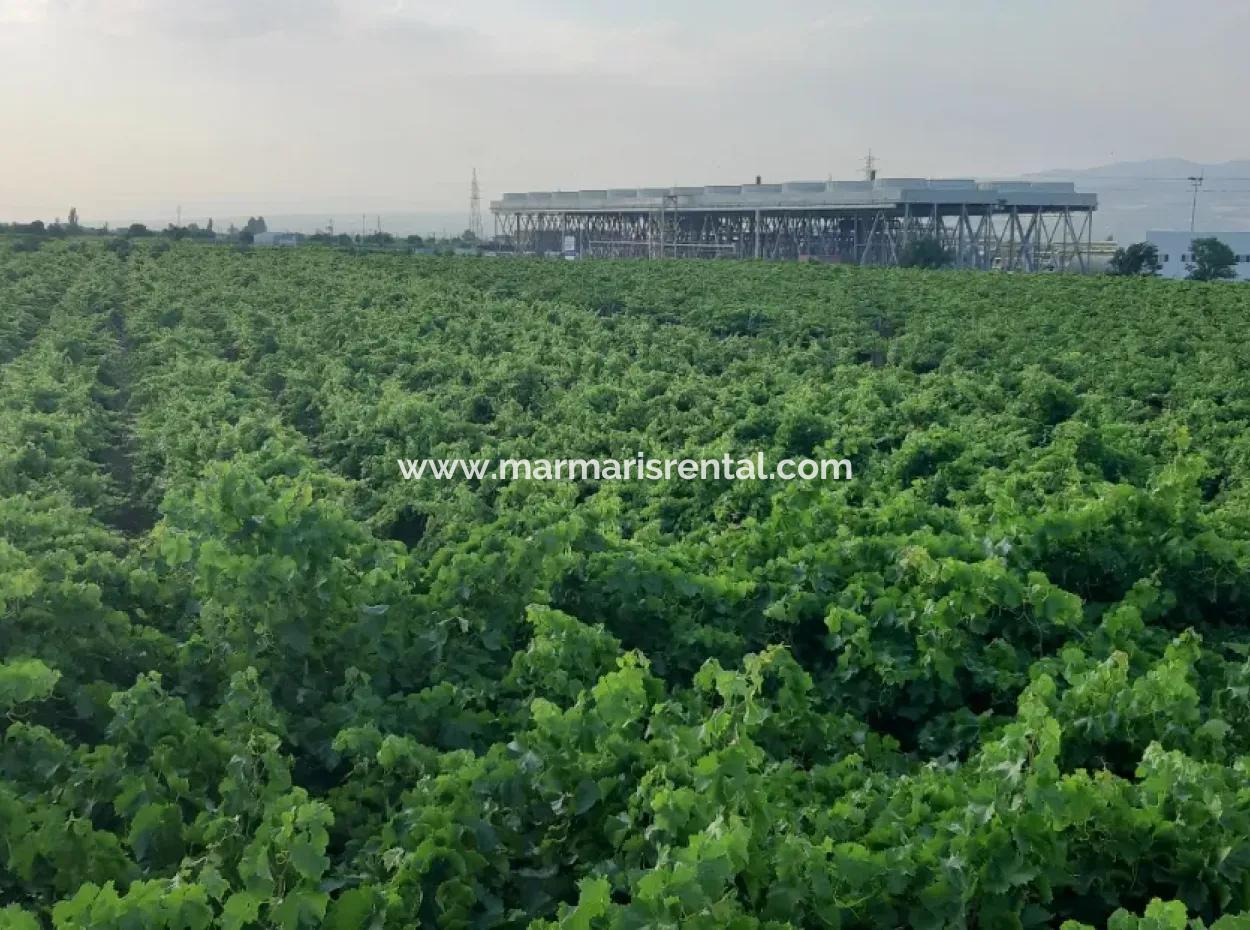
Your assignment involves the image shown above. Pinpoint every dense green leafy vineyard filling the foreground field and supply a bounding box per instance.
[0,240,1250,930]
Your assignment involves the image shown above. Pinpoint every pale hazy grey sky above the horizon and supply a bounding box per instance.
[0,0,1250,219]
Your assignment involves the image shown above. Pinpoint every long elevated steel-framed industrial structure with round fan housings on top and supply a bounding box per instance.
[490,178,1098,271]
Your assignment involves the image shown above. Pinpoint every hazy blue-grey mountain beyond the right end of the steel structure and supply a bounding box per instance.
[1024,159,1250,243]
